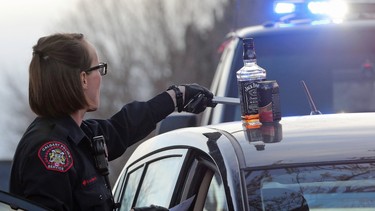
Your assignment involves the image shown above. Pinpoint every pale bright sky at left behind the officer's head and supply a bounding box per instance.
[0,0,77,159]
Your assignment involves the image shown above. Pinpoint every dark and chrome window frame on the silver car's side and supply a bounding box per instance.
[115,148,229,210]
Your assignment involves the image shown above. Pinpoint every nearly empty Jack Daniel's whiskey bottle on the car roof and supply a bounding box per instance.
[236,38,266,128]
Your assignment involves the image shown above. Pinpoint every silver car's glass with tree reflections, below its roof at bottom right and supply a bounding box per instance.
[245,163,375,210]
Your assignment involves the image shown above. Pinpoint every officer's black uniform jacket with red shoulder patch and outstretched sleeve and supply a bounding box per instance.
[10,92,174,210]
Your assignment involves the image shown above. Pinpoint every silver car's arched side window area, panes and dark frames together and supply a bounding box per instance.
[114,148,228,211]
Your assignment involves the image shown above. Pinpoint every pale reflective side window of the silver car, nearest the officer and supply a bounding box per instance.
[119,150,186,211]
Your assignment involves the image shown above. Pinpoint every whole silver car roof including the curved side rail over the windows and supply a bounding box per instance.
[129,113,375,168]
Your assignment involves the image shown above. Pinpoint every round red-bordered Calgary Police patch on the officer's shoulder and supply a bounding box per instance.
[38,141,73,172]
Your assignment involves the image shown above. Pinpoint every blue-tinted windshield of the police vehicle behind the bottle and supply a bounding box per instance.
[224,23,375,121]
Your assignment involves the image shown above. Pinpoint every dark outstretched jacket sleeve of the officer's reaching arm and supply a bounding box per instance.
[85,92,175,160]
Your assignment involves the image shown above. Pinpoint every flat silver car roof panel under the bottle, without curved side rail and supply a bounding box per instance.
[212,113,375,167]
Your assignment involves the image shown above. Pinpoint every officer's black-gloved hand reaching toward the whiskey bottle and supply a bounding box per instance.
[181,83,216,114]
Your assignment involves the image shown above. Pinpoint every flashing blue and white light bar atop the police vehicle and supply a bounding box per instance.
[274,0,348,19]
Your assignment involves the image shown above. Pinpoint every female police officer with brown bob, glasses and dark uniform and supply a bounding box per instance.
[10,34,213,210]
